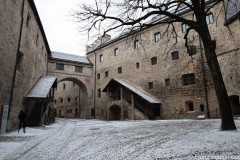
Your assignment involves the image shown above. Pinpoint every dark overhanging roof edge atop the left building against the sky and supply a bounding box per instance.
[28,0,51,55]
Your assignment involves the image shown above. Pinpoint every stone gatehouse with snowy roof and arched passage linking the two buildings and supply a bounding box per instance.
[48,52,93,118]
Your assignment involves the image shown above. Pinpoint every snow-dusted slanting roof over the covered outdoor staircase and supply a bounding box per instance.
[103,78,160,104]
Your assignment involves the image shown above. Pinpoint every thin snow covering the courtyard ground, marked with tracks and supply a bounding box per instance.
[0,119,240,160]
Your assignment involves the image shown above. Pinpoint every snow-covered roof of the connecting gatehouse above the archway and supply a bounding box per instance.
[51,52,91,64]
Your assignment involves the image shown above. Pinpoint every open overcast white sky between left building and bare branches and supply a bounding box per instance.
[34,0,92,56]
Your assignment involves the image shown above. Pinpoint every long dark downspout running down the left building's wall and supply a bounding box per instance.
[7,0,25,128]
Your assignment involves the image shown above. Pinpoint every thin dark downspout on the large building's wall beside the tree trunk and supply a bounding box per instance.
[199,37,210,118]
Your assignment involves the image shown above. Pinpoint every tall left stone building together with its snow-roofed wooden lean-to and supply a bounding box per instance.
[0,0,56,130]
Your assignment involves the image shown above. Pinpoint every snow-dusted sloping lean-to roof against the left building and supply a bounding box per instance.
[25,76,57,99]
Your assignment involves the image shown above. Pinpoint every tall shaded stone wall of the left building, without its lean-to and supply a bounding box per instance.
[0,0,50,130]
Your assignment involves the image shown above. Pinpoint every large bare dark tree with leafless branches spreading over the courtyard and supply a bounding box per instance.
[74,0,236,130]
